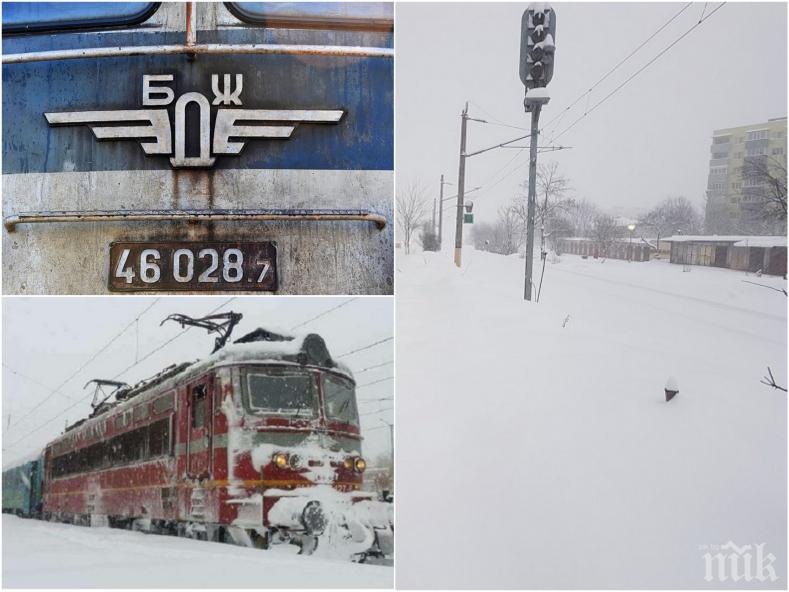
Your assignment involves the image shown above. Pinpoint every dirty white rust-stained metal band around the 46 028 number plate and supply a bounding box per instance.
[2,169,394,294]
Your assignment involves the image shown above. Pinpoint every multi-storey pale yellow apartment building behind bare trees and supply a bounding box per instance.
[705,117,786,234]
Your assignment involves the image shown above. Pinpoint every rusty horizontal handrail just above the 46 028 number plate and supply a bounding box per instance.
[3,209,386,232]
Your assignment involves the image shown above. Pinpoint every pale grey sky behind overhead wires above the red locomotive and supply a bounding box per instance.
[2,296,393,466]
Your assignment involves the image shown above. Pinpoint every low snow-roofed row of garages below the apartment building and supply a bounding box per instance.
[661,235,786,276]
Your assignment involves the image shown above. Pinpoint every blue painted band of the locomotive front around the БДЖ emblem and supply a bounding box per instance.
[2,29,394,173]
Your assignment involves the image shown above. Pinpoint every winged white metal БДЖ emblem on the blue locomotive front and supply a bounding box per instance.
[44,74,344,168]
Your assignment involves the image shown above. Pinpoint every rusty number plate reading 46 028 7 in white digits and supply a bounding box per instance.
[109,242,278,292]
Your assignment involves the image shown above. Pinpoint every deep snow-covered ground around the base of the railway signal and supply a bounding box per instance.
[396,248,787,589]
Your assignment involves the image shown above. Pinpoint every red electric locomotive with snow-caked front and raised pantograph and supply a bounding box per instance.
[43,313,394,560]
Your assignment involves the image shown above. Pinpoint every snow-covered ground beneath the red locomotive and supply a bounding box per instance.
[2,514,394,589]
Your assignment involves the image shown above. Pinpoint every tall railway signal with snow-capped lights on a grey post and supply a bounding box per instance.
[520,2,556,300]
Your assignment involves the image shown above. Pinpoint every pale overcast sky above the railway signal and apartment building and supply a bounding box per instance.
[396,2,787,228]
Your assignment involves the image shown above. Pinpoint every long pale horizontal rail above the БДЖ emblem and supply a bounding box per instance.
[3,43,394,64]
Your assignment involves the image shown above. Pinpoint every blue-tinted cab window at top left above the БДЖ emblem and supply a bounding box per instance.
[3,2,159,33]
